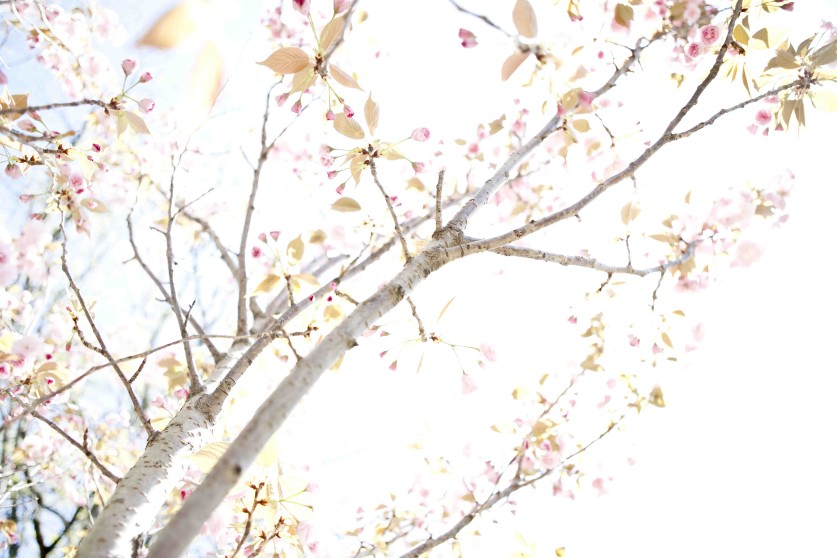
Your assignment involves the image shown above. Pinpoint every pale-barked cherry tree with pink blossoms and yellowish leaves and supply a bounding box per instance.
[0,0,837,557]
